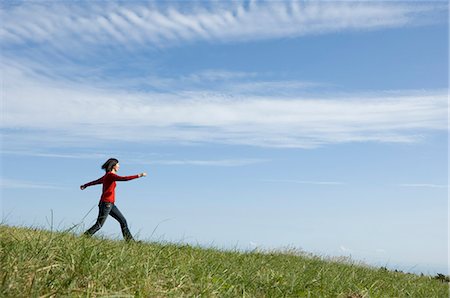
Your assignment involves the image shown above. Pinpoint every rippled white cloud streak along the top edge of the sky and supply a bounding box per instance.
[0,1,446,50]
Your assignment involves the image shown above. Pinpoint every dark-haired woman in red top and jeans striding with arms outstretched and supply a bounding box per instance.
[80,158,147,241]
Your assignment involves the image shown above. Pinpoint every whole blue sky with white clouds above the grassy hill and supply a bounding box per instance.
[0,1,449,274]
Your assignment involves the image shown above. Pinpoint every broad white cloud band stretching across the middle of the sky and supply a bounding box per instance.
[2,67,447,149]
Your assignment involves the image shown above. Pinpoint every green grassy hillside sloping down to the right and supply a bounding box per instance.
[0,225,449,297]
